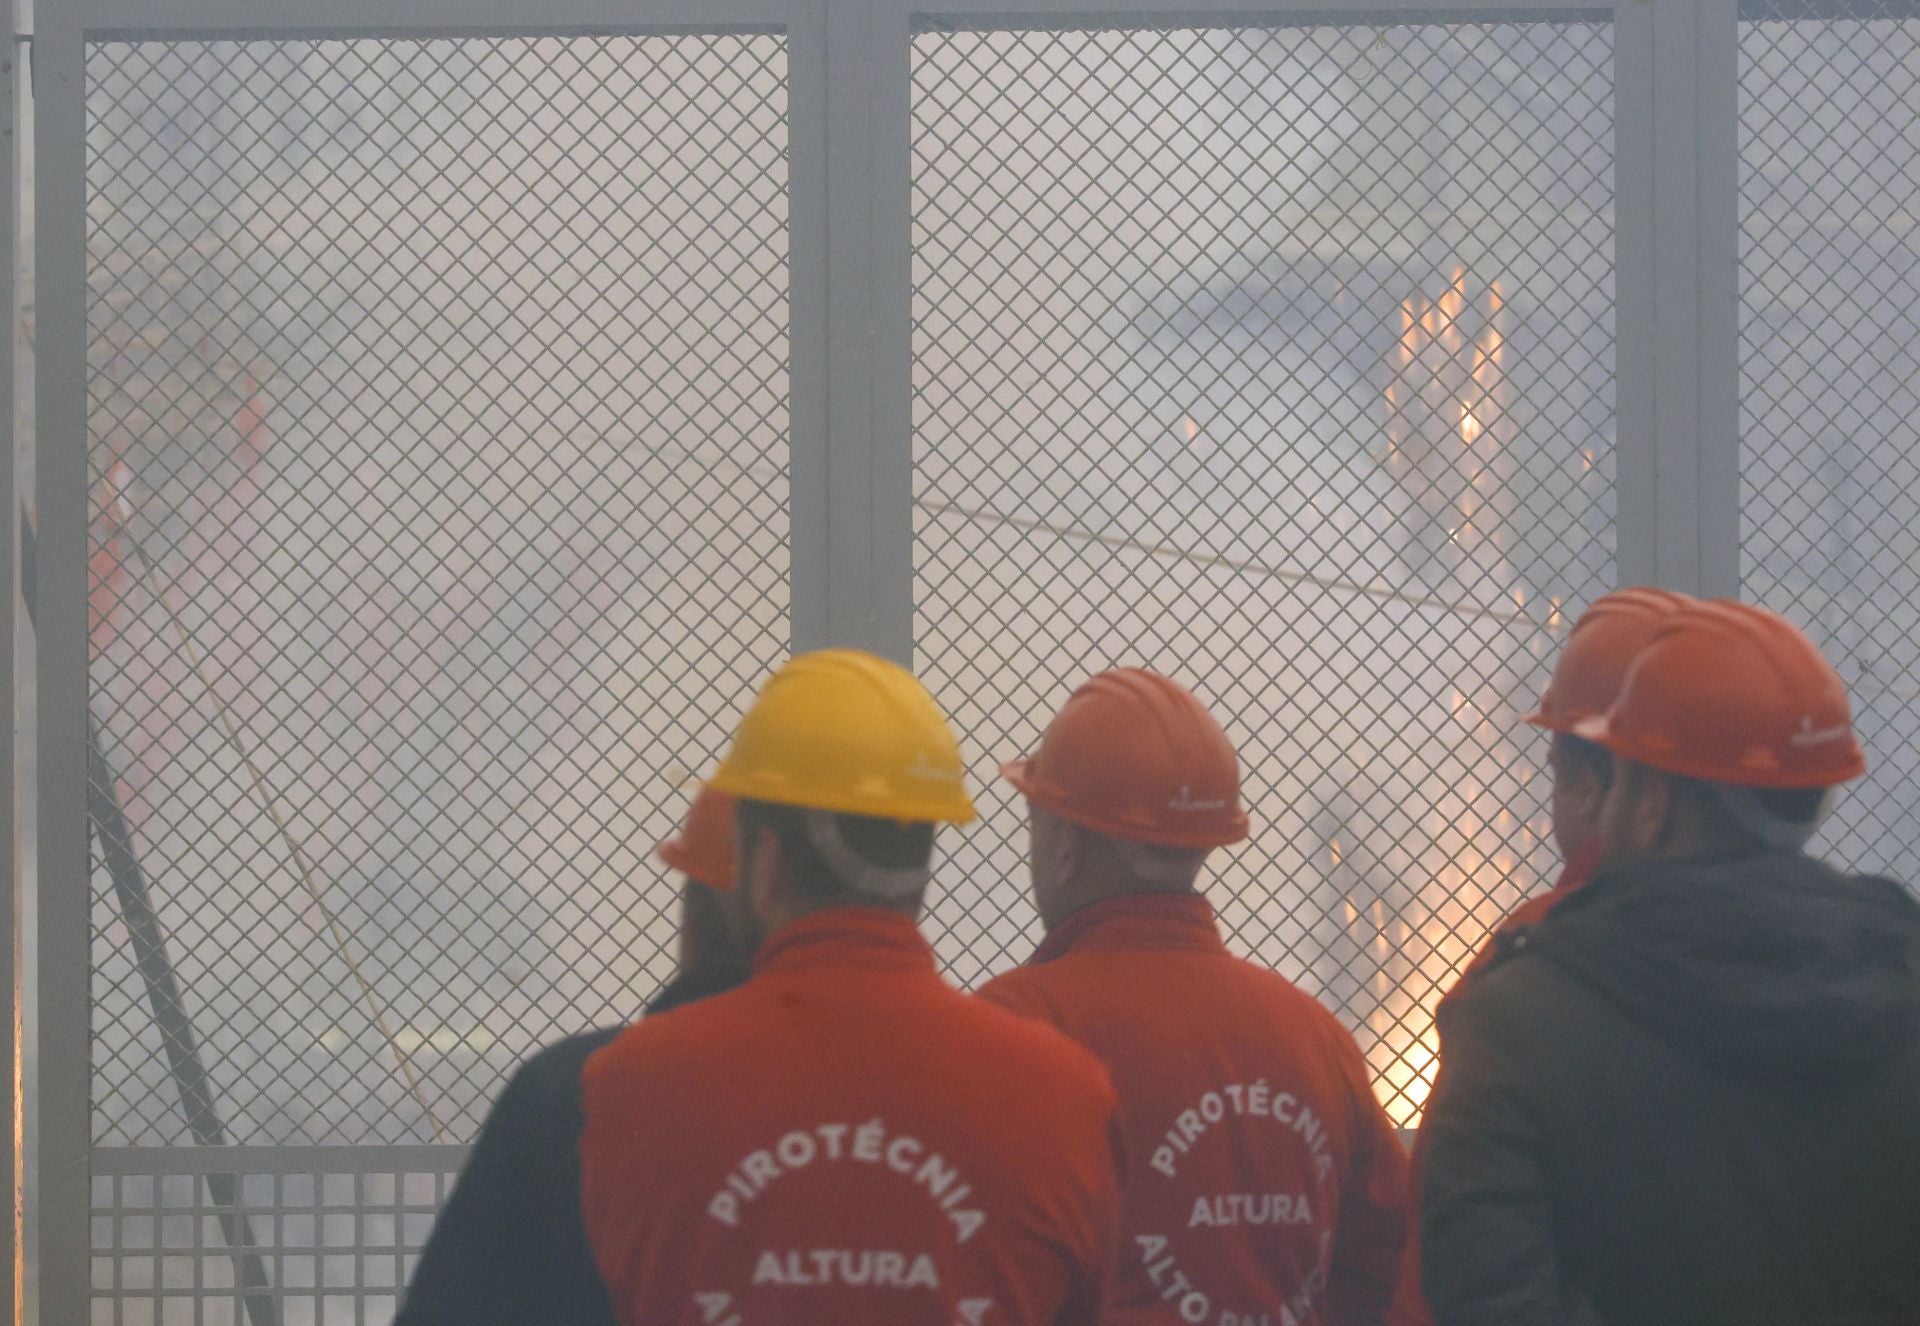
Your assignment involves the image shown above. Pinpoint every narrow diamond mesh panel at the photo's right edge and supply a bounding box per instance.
[1740,4,1920,883]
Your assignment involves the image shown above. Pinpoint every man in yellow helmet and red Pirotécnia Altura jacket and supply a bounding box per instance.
[580,651,1117,1326]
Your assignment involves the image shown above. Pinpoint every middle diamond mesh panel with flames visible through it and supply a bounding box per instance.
[912,23,1615,1123]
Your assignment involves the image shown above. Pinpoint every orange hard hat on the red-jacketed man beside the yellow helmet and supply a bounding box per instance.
[1000,668,1246,848]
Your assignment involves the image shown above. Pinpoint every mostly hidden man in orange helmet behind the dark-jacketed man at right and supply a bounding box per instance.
[1392,587,1693,1326]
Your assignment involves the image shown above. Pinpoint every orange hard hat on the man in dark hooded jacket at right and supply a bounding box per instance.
[1574,599,1866,789]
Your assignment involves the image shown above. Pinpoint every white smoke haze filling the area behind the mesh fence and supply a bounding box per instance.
[29,12,1920,1320]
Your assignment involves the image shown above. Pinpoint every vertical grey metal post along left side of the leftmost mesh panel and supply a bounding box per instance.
[33,6,92,1326]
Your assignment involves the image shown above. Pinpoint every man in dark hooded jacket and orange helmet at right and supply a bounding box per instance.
[1423,603,1920,1326]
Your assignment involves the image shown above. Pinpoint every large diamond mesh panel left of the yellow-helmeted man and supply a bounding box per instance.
[86,35,787,1151]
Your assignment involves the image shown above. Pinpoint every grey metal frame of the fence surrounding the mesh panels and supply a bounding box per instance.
[30,0,1766,1322]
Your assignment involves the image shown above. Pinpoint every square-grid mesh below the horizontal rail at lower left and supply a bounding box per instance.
[92,1167,453,1326]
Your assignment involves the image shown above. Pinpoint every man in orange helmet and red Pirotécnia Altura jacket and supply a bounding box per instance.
[981,668,1409,1326]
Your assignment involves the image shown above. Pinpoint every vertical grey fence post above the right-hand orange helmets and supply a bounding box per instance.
[1615,0,1740,595]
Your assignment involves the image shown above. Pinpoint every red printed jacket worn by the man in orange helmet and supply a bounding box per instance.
[981,894,1407,1326]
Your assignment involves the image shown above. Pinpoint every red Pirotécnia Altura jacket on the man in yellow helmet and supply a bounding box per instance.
[580,908,1117,1326]
